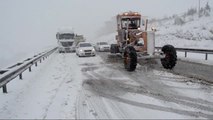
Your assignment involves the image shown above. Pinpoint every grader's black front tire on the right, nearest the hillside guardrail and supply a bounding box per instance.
[161,45,177,69]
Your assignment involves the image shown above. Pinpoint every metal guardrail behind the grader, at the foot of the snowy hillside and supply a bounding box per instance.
[155,47,213,60]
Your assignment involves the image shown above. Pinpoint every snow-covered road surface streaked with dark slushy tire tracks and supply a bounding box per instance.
[0,53,213,119]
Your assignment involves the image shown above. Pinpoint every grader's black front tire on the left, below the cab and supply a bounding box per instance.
[124,46,137,72]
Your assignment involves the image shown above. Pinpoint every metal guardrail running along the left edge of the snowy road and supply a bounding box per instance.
[0,47,58,93]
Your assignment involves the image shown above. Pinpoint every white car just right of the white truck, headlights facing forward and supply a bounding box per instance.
[76,42,96,57]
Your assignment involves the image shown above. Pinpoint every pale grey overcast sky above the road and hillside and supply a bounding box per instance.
[0,0,213,47]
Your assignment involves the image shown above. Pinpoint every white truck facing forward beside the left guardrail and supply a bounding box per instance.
[56,30,75,53]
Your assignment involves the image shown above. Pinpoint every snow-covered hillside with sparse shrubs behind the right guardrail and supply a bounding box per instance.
[155,8,213,49]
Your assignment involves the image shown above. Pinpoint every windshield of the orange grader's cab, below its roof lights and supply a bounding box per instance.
[121,18,140,29]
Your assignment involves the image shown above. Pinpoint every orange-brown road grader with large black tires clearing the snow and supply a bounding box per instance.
[110,11,177,71]
